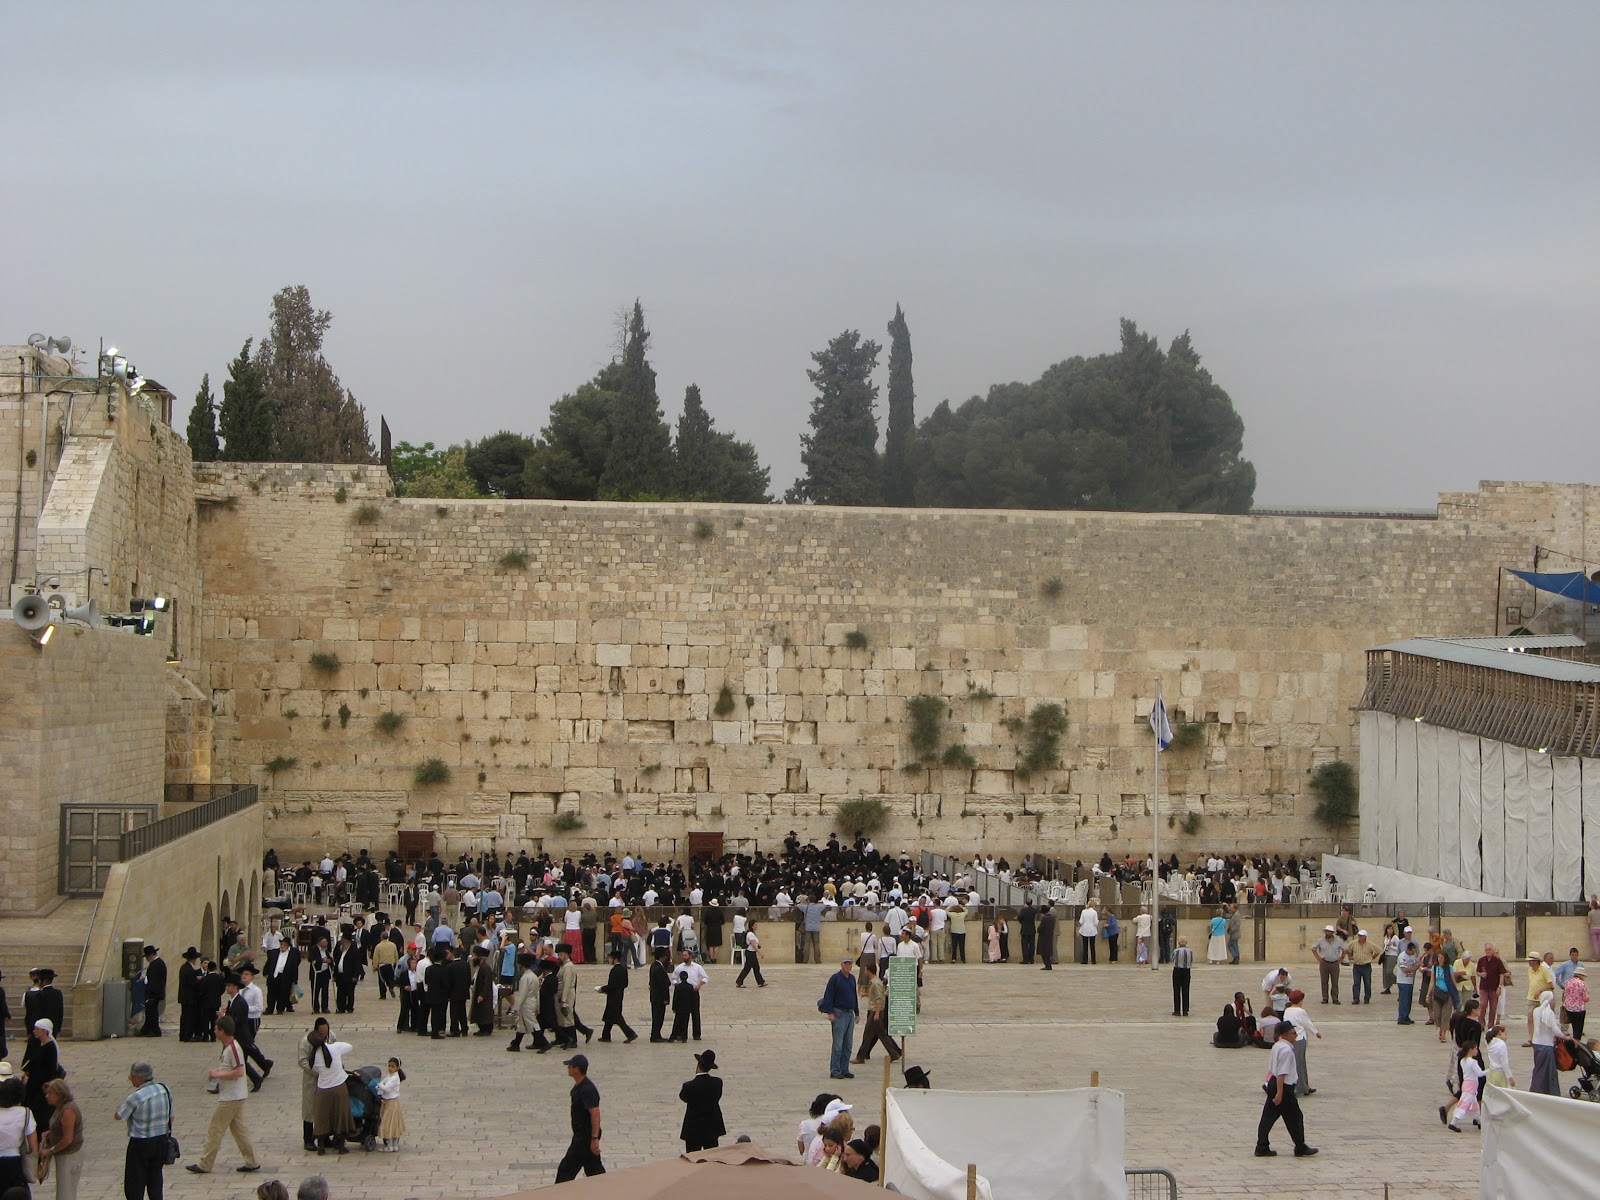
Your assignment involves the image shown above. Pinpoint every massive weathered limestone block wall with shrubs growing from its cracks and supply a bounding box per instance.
[198,464,1584,856]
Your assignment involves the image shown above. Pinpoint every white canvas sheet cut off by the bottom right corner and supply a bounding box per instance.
[1478,1086,1600,1200]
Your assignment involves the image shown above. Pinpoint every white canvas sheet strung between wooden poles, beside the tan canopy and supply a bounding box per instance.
[883,1088,1128,1200]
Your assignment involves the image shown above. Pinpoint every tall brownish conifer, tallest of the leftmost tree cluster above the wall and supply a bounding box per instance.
[256,285,374,462]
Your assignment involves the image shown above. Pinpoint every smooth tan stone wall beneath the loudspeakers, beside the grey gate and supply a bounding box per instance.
[0,621,166,914]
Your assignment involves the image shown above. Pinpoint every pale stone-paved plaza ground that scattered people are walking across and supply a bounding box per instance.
[50,963,1497,1200]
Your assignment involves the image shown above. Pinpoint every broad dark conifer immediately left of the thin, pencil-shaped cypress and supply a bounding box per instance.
[784,330,882,504]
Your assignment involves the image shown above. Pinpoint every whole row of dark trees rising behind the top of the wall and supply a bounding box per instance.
[189,294,1256,512]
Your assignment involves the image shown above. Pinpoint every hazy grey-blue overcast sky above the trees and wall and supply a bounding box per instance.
[0,0,1600,506]
